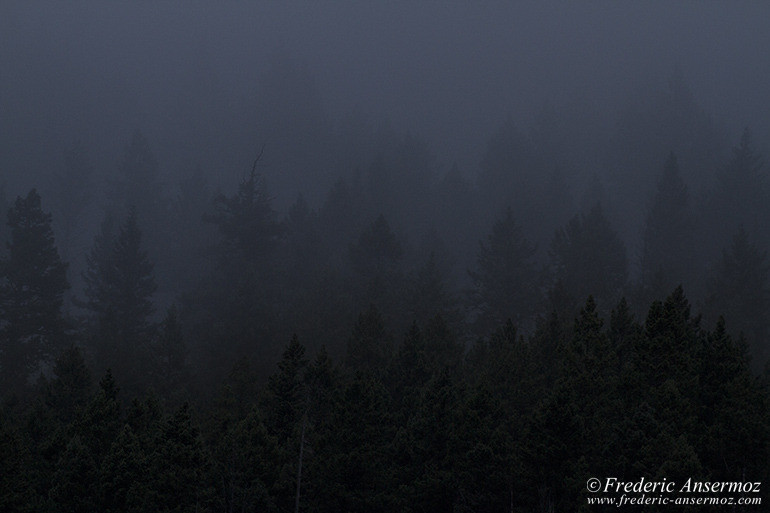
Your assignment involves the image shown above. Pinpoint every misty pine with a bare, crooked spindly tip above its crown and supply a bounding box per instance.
[195,162,286,380]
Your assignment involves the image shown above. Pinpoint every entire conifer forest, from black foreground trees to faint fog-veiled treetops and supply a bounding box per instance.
[0,75,770,511]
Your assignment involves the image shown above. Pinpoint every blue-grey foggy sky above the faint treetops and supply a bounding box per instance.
[0,1,770,206]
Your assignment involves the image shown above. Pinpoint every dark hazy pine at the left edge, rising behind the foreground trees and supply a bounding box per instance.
[0,189,69,393]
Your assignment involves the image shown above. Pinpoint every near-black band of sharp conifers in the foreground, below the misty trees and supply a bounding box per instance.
[0,288,770,512]
